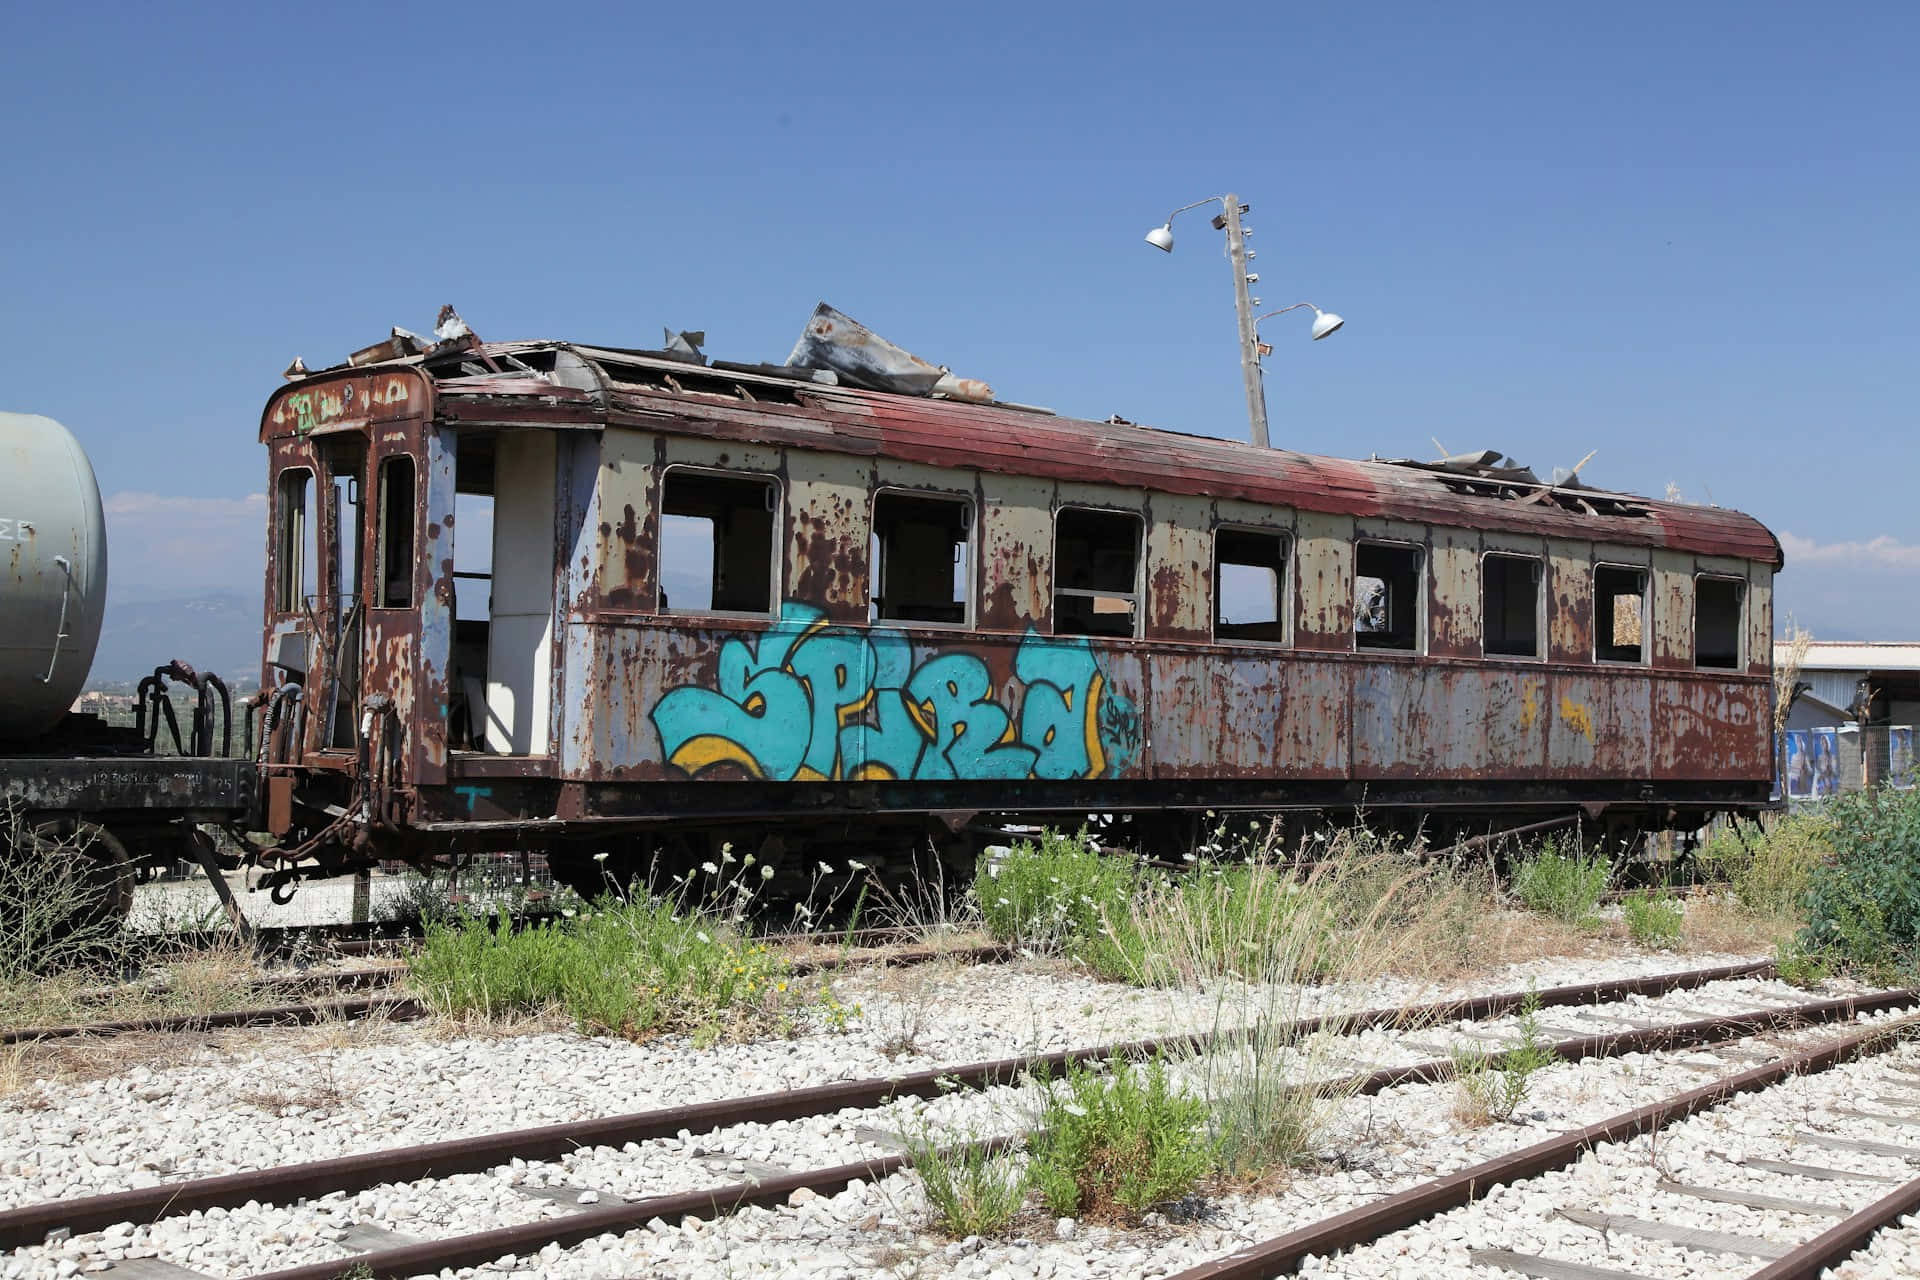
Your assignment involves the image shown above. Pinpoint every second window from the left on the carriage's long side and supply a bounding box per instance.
[868,491,973,626]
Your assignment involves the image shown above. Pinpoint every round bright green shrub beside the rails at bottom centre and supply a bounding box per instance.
[1029,1059,1213,1222]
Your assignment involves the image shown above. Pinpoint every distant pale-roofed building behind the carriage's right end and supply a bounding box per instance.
[1774,641,1920,800]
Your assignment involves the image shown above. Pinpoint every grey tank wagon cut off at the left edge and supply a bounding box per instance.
[0,413,252,927]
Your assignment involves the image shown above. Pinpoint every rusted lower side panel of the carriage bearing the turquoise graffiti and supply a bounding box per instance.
[588,601,1150,781]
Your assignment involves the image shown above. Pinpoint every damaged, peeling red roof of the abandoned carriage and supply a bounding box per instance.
[261,340,1784,568]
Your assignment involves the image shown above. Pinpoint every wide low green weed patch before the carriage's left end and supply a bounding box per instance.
[411,900,858,1042]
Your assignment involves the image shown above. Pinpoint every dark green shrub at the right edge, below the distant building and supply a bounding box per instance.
[1801,787,1920,979]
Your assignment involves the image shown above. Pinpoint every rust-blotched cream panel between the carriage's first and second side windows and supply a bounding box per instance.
[785,451,874,622]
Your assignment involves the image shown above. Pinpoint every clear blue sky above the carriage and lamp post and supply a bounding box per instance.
[0,4,1920,639]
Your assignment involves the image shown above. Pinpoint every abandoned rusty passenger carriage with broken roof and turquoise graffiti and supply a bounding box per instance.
[261,342,1782,890]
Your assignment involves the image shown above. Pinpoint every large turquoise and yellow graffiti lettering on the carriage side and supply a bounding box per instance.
[651,601,1137,781]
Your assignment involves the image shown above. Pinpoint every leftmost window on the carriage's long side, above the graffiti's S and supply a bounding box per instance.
[660,468,780,614]
